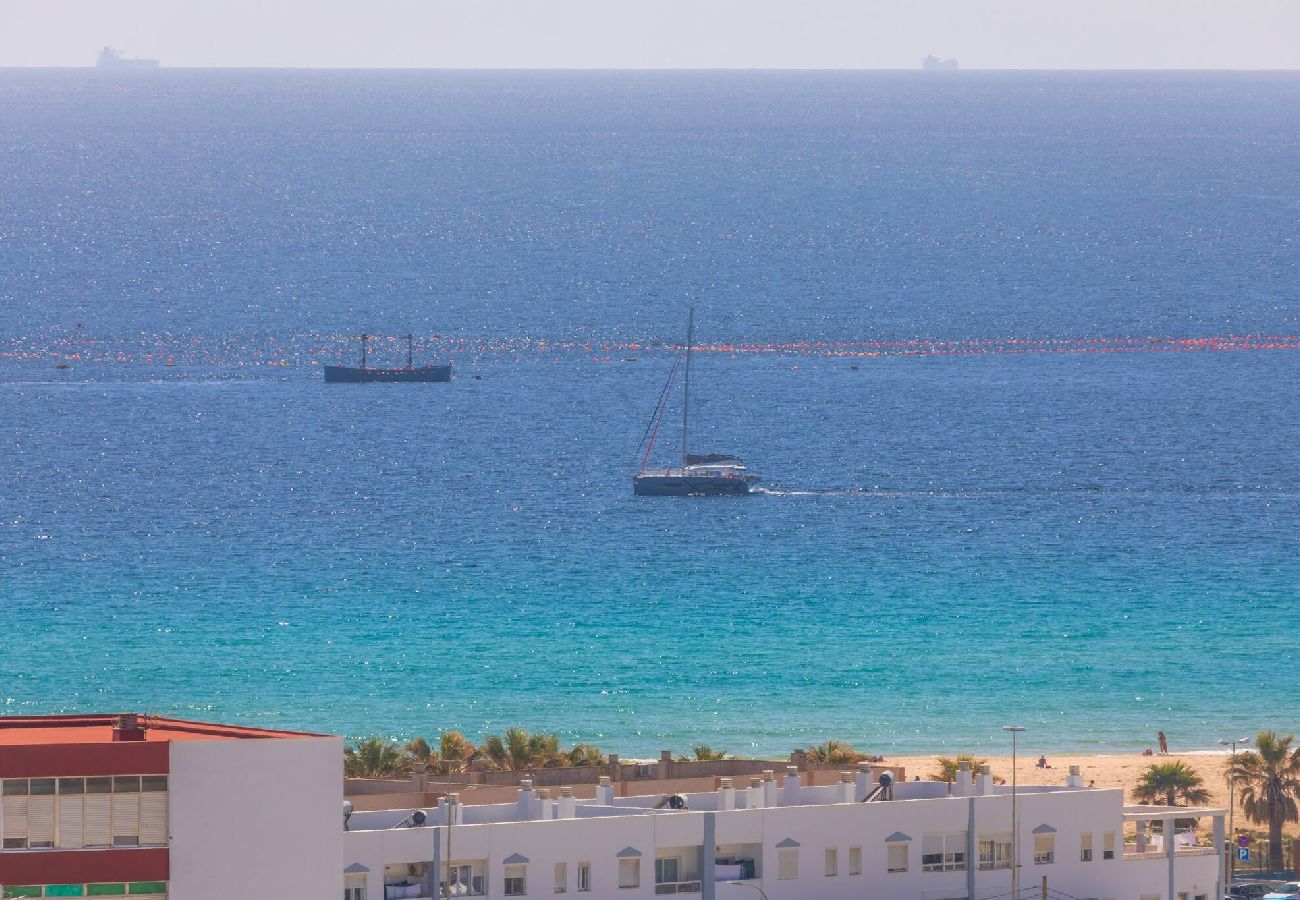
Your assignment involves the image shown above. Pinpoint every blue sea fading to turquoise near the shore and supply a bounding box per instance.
[0,69,1300,756]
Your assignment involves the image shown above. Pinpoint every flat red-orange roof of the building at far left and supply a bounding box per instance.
[0,713,328,747]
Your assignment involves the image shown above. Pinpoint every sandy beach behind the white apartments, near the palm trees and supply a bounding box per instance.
[885,753,1300,836]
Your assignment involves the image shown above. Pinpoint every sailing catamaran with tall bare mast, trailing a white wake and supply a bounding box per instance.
[632,310,761,497]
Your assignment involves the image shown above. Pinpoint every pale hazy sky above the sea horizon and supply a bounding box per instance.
[0,0,1300,69]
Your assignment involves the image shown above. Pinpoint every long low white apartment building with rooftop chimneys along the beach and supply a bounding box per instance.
[341,767,1226,900]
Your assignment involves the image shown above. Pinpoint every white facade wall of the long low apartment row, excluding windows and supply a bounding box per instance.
[343,789,1217,900]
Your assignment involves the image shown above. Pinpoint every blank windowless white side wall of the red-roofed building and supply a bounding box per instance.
[169,737,343,900]
